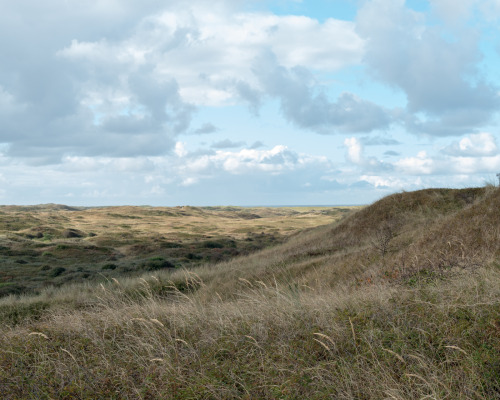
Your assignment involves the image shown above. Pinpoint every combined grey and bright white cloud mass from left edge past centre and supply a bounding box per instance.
[0,0,370,164]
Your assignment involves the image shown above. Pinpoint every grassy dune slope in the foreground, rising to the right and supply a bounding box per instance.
[0,187,500,399]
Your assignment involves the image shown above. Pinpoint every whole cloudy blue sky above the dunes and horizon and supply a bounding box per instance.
[0,0,500,206]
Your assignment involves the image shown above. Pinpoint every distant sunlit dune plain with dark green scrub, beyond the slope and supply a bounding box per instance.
[0,204,356,296]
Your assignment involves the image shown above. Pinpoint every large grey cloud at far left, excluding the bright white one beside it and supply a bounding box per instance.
[0,1,201,164]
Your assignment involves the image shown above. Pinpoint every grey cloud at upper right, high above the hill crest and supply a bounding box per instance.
[357,0,500,136]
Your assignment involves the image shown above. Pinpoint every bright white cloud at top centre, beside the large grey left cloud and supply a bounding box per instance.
[59,6,364,105]
